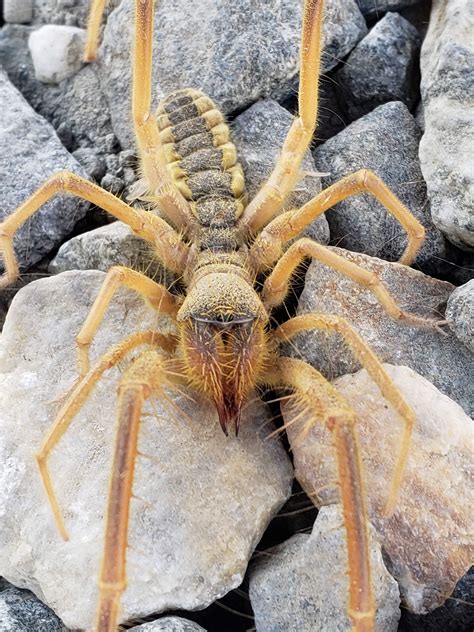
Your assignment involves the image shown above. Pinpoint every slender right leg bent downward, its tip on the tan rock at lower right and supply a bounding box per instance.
[274,314,415,515]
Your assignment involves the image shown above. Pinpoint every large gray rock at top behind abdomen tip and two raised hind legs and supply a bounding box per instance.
[99,0,367,148]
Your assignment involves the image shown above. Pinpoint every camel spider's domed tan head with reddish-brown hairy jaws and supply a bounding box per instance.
[178,273,268,435]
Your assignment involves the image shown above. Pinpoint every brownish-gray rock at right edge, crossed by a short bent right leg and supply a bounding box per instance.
[294,248,474,414]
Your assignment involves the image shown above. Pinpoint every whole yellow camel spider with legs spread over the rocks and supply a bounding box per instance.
[0,0,439,632]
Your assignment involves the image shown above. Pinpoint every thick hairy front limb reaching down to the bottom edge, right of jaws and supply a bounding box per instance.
[265,356,375,632]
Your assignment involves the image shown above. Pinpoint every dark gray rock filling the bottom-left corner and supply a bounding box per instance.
[0,586,68,632]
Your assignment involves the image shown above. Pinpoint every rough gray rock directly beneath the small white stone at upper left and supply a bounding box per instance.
[0,25,117,154]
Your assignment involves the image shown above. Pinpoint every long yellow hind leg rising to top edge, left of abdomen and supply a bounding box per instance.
[132,0,195,229]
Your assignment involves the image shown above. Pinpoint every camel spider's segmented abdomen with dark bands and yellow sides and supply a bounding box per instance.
[157,89,245,251]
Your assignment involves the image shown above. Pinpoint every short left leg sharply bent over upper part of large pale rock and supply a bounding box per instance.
[76,266,181,378]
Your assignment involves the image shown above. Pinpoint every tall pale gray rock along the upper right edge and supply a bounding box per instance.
[420,0,474,251]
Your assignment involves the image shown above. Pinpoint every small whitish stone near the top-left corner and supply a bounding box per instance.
[28,24,86,83]
